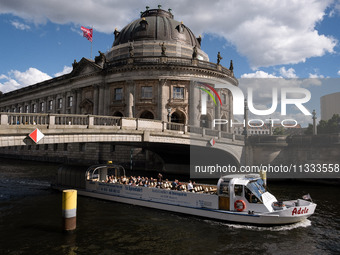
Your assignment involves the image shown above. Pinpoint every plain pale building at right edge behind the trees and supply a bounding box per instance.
[320,92,340,120]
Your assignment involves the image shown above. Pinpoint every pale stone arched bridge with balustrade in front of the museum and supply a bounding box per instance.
[0,113,245,171]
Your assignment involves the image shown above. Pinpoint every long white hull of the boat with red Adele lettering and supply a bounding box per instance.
[55,182,316,225]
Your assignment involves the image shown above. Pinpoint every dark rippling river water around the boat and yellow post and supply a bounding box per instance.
[0,159,340,255]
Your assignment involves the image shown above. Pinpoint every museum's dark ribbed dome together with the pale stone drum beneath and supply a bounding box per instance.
[106,8,209,61]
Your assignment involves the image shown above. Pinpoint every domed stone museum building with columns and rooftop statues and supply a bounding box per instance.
[0,9,238,132]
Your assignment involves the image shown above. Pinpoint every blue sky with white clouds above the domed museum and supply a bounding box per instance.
[0,0,340,126]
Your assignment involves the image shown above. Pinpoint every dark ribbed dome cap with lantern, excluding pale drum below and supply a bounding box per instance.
[112,9,200,48]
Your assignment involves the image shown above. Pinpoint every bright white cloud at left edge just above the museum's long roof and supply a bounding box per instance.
[0,67,52,93]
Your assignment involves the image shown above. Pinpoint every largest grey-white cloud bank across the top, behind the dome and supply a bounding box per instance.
[0,0,337,69]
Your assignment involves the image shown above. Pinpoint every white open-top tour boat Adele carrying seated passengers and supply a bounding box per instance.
[57,164,316,225]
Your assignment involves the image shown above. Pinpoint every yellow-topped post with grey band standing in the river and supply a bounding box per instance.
[62,189,77,231]
